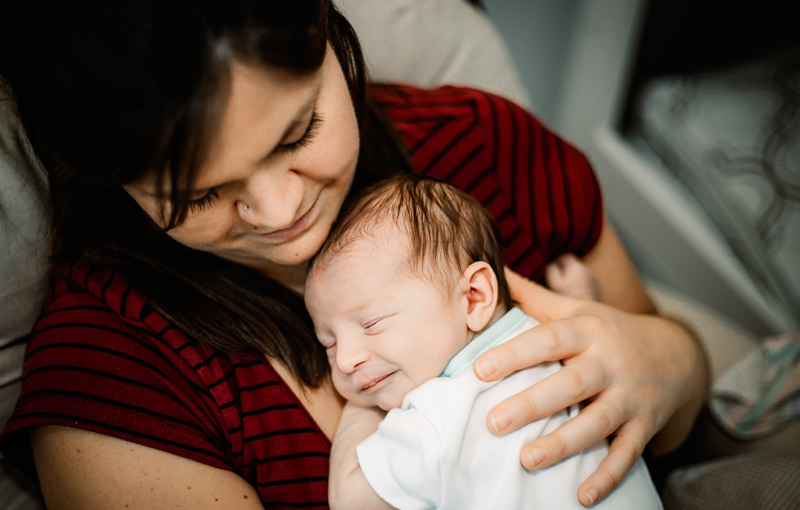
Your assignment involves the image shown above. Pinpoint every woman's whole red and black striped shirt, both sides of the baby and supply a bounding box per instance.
[0,87,602,508]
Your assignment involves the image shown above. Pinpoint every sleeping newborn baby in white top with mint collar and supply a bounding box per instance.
[305,175,661,510]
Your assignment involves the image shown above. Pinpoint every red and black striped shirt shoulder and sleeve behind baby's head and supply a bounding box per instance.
[373,85,603,280]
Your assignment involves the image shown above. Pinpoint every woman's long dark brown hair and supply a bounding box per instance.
[0,0,410,387]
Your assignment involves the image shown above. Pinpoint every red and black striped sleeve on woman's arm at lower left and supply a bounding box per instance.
[0,284,233,478]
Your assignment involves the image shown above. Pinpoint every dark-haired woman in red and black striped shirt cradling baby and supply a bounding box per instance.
[0,0,707,509]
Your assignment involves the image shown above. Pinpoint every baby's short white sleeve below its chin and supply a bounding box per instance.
[356,407,442,510]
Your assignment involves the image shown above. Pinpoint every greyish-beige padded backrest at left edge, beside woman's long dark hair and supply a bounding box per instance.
[0,78,50,510]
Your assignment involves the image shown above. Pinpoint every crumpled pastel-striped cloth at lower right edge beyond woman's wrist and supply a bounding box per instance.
[709,331,800,439]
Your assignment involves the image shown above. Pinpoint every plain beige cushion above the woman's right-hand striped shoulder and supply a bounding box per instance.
[334,0,530,108]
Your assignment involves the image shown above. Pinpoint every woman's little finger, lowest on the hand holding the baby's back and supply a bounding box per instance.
[578,421,647,506]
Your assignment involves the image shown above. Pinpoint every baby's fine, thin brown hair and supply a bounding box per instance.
[312,174,514,310]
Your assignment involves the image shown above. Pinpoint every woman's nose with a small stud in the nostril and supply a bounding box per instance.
[239,169,305,231]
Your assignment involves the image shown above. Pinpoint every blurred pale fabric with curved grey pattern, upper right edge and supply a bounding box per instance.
[634,48,800,328]
